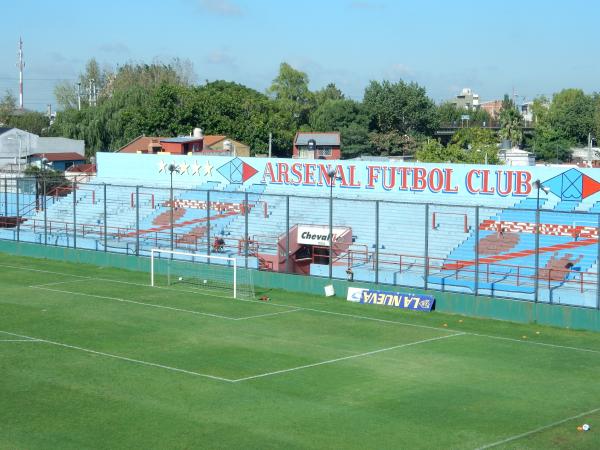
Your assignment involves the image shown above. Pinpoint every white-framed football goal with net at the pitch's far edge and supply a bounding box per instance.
[150,248,254,300]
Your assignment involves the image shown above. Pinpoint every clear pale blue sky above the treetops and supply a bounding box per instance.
[0,0,600,110]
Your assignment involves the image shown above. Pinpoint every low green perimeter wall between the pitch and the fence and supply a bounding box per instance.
[0,240,600,331]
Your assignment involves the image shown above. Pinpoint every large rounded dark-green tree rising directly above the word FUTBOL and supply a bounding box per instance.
[363,81,438,136]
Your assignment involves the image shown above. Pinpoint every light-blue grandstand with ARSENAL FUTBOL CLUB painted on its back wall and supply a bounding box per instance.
[0,153,600,307]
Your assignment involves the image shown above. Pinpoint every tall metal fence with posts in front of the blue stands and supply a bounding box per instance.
[0,177,600,308]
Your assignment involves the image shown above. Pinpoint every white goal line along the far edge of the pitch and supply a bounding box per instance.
[5,264,600,353]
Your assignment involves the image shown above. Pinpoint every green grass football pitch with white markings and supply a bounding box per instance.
[0,254,600,449]
